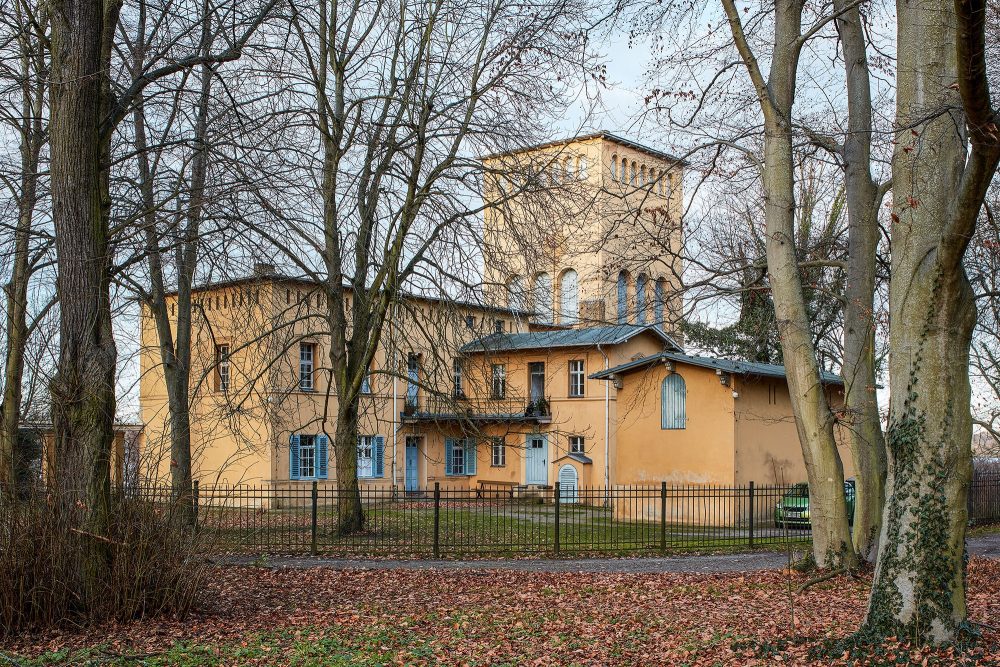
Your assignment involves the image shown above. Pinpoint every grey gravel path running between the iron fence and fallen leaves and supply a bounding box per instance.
[223,533,1000,573]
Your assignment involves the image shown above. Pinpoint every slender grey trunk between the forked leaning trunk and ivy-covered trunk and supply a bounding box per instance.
[834,0,886,562]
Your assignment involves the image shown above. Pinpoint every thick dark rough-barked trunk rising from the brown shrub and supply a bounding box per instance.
[50,0,119,603]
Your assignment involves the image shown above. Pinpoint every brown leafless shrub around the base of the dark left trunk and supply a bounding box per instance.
[0,490,204,636]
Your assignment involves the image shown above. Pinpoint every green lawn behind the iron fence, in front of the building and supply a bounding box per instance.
[202,501,809,557]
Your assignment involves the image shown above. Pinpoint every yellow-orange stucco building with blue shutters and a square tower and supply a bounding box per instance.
[140,132,850,504]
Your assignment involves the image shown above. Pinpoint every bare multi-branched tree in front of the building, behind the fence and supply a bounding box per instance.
[236,0,584,532]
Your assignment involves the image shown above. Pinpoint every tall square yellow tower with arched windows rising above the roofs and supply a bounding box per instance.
[483,131,685,331]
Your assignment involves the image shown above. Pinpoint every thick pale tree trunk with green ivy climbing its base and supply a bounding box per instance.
[864,0,1000,643]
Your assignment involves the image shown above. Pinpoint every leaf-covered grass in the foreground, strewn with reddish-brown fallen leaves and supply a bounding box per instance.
[7,560,1000,666]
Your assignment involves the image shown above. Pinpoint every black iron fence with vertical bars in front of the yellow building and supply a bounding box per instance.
[115,479,968,558]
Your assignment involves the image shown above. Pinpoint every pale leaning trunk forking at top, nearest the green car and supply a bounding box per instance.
[723,0,856,568]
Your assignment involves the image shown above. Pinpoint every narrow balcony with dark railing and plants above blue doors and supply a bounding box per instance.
[400,395,552,424]
